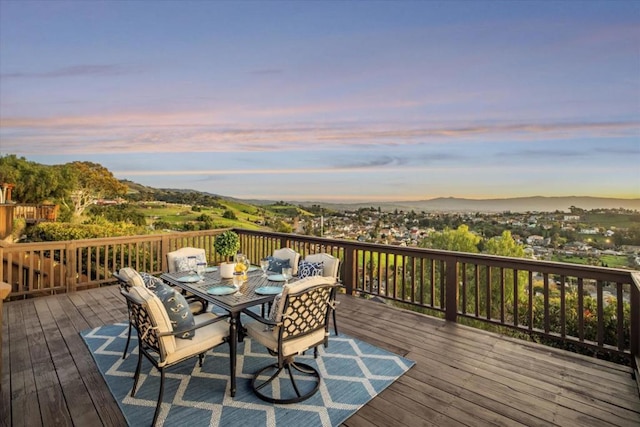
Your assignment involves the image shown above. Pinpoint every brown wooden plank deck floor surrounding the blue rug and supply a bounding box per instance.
[0,286,640,427]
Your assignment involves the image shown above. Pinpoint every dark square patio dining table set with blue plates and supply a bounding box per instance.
[160,266,283,397]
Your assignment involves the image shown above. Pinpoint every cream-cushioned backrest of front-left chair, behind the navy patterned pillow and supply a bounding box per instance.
[120,286,176,360]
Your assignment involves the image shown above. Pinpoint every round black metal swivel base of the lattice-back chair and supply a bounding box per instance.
[251,362,321,404]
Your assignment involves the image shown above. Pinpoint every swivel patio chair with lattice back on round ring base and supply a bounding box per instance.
[244,276,336,404]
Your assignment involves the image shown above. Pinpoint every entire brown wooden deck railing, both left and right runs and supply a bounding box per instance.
[0,229,640,372]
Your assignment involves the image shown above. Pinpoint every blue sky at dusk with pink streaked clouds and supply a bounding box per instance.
[0,0,640,202]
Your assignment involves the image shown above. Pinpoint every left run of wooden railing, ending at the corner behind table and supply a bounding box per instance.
[0,230,229,299]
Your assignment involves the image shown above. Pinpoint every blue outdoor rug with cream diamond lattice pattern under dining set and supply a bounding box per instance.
[80,323,415,427]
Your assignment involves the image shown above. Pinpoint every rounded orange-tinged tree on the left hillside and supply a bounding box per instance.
[62,162,128,221]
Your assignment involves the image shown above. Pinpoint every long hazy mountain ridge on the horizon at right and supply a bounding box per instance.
[309,196,640,213]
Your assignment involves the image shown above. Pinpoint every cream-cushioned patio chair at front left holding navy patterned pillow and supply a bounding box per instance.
[121,286,229,426]
